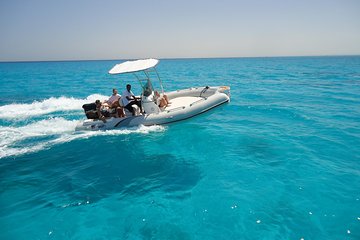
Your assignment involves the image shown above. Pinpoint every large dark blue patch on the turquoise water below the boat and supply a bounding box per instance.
[3,136,201,210]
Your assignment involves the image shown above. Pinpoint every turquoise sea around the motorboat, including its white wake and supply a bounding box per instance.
[0,56,360,240]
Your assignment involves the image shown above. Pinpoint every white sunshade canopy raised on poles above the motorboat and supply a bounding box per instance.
[109,58,159,74]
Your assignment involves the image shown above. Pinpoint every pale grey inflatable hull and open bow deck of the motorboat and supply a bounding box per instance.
[76,87,230,131]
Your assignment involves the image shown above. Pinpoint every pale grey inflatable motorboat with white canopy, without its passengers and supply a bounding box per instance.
[76,59,230,131]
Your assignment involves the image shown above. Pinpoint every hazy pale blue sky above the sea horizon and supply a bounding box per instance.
[0,0,360,61]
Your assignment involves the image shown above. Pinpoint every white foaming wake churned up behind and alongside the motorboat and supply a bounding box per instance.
[0,94,165,158]
